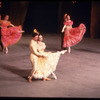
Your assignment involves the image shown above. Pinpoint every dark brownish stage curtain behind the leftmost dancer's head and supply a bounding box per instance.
[1,1,29,26]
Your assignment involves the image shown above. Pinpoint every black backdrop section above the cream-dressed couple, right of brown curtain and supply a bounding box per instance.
[24,1,58,33]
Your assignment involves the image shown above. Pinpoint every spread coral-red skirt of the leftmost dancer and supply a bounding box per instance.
[1,26,22,48]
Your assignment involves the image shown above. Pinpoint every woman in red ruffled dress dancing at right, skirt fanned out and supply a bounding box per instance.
[62,14,86,53]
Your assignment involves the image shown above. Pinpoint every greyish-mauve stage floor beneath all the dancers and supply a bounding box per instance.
[0,33,100,98]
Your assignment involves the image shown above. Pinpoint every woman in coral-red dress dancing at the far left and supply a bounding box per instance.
[1,15,24,54]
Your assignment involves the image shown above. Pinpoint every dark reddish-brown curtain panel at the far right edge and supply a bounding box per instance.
[90,1,100,38]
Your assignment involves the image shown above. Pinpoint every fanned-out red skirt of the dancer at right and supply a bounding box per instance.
[63,24,86,47]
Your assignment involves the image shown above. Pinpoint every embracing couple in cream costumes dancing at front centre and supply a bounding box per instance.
[28,33,67,82]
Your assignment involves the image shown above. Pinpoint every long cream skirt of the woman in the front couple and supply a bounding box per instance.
[32,51,61,79]
